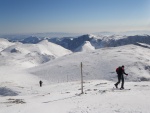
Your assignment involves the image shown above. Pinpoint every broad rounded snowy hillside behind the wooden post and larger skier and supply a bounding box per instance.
[30,45,150,82]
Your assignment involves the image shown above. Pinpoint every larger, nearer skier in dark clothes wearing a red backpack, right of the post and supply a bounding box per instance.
[114,66,128,89]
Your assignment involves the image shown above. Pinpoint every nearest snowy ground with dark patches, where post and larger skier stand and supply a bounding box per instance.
[0,77,150,113]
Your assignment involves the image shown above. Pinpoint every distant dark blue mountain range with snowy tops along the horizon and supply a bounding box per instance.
[2,34,150,52]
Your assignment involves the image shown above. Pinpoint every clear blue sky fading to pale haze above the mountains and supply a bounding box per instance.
[0,0,150,33]
